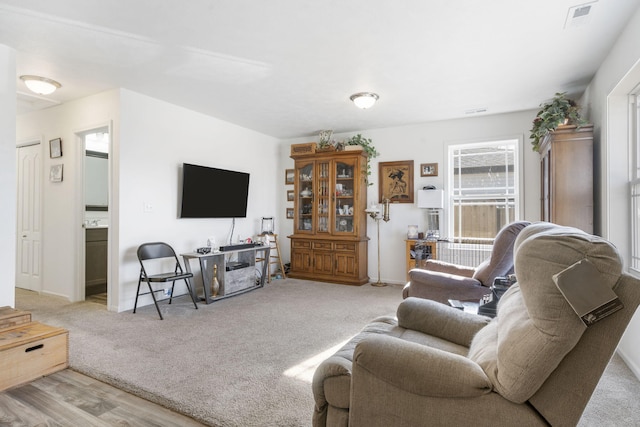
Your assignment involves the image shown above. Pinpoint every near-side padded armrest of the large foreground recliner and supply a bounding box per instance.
[352,335,492,399]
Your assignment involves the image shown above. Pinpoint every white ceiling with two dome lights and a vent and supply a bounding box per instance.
[0,0,640,138]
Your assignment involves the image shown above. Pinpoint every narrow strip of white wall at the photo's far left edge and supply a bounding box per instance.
[0,45,17,307]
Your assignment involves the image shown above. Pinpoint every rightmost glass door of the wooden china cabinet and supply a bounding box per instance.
[334,160,356,234]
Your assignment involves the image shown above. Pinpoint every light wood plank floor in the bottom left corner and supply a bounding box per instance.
[0,369,203,427]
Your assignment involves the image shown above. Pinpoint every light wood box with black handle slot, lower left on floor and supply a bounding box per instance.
[0,322,69,391]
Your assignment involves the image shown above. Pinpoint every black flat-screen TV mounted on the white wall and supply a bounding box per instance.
[180,163,249,218]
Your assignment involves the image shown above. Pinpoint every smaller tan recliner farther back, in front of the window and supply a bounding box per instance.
[402,221,530,304]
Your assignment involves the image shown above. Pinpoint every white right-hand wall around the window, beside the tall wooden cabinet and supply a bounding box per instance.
[583,5,640,378]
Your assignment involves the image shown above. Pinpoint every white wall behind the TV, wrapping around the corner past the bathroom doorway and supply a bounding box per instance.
[16,88,280,311]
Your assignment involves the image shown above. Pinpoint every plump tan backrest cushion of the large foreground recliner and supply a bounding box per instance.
[469,223,622,403]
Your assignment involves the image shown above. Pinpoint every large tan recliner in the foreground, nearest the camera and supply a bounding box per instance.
[313,223,640,427]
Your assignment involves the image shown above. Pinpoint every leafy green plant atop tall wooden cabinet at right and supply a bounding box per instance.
[531,92,587,151]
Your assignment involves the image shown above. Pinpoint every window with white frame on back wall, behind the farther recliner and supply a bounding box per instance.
[448,139,521,241]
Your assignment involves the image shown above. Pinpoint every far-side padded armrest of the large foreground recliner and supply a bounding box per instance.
[397,297,491,347]
